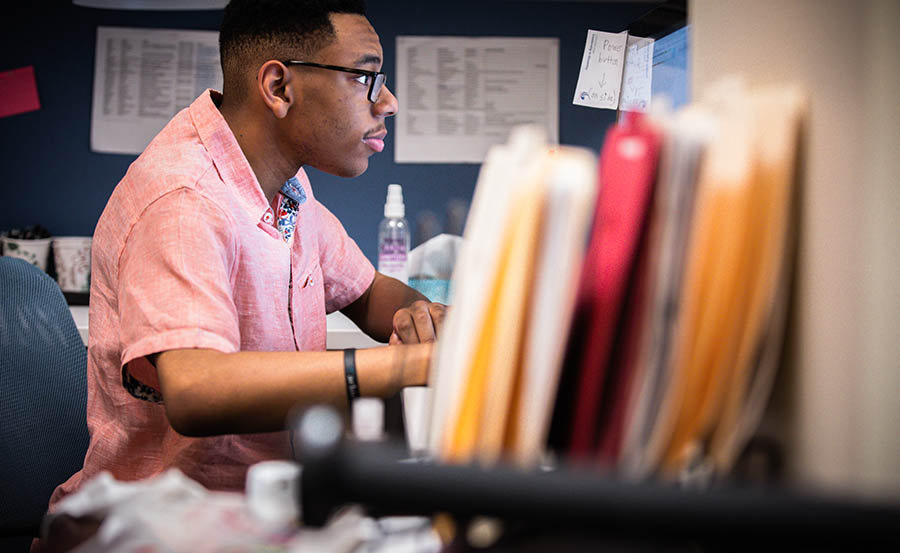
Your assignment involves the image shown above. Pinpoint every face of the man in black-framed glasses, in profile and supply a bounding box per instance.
[285,14,397,177]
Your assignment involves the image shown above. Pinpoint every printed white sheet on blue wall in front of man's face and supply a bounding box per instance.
[394,36,559,163]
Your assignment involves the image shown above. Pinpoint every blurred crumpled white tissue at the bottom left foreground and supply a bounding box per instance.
[42,469,381,553]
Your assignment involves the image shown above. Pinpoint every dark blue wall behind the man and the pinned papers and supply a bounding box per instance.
[0,0,652,260]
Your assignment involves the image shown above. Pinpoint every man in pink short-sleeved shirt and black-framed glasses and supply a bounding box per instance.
[45,0,444,516]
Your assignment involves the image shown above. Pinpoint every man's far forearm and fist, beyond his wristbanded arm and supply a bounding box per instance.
[341,272,446,344]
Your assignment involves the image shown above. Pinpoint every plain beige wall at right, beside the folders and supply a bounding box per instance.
[689,0,900,495]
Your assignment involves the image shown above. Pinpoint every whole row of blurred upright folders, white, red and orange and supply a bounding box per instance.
[427,83,806,481]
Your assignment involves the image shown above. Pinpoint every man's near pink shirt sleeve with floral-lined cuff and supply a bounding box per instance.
[118,188,240,398]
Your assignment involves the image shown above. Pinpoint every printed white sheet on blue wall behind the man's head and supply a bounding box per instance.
[91,27,222,154]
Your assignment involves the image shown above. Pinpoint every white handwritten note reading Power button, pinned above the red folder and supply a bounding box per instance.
[572,30,653,110]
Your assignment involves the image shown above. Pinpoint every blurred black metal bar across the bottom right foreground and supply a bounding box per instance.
[300,404,900,551]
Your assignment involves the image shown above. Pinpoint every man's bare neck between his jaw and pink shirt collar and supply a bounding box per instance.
[219,101,300,204]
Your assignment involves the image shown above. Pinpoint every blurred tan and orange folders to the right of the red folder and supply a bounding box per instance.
[592,84,804,478]
